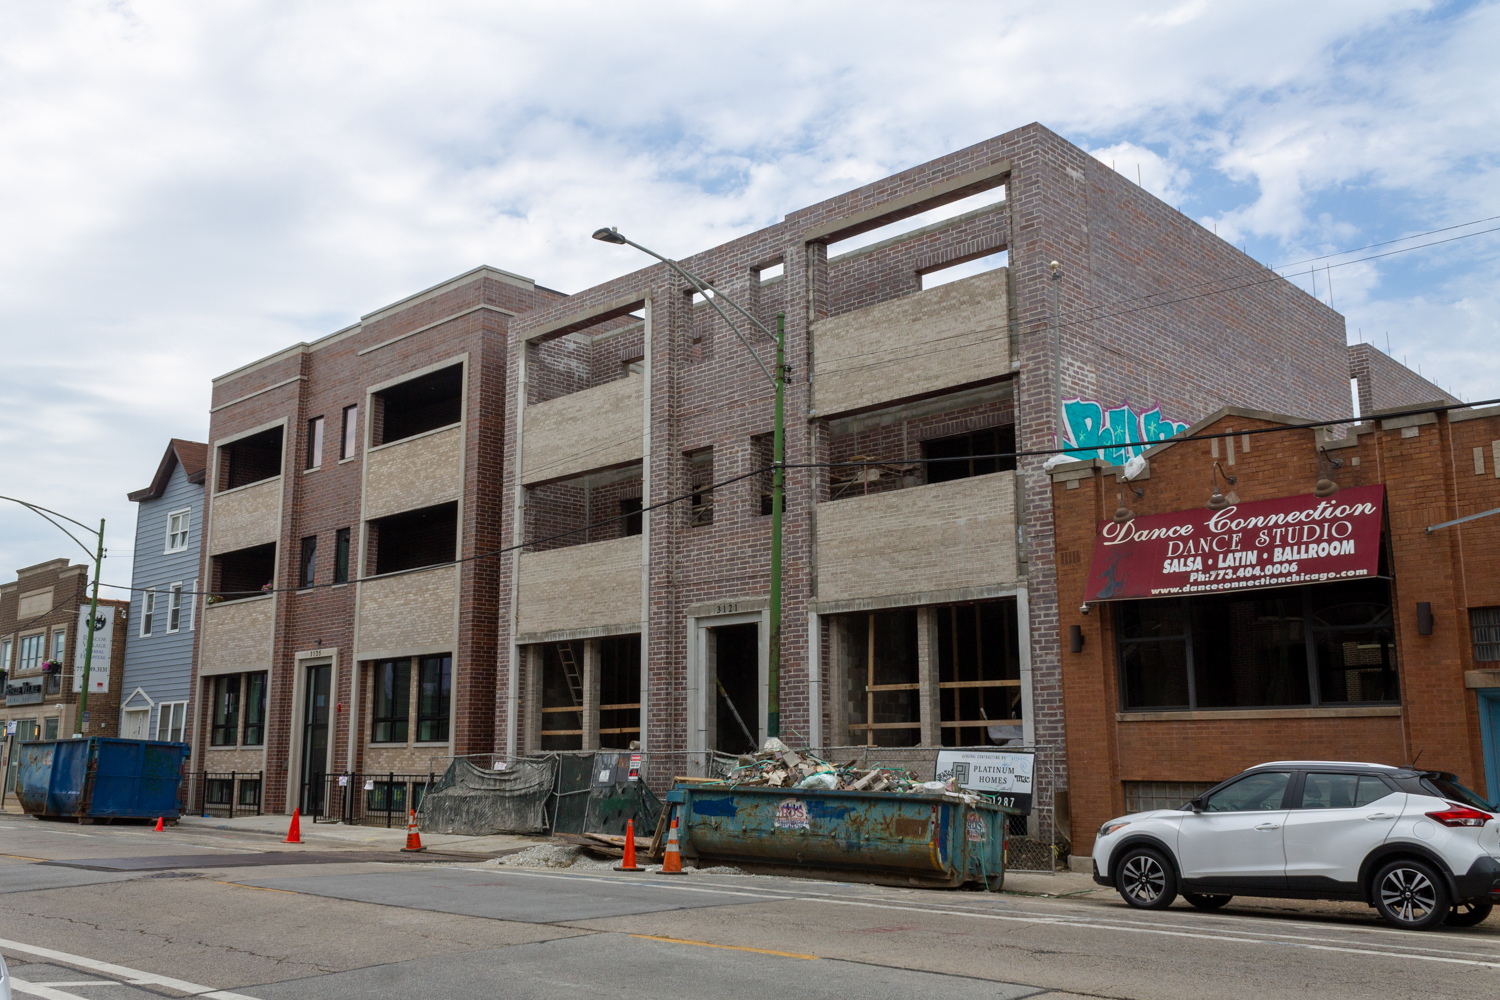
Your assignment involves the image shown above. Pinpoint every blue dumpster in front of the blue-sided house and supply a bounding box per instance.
[17,736,188,820]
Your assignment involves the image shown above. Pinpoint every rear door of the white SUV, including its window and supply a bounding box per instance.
[1284,774,1407,889]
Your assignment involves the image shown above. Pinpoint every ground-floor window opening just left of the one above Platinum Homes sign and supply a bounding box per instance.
[842,607,923,747]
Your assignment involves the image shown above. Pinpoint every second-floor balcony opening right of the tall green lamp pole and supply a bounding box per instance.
[825,381,1016,501]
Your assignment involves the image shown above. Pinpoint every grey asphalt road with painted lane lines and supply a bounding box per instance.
[0,817,1500,1000]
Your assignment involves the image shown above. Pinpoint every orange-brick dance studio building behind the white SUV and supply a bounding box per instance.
[1052,401,1500,862]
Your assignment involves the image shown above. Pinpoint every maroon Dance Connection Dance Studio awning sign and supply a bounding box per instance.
[1086,486,1386,601]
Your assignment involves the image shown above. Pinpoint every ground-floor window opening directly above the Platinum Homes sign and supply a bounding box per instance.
[933,600,1025,747]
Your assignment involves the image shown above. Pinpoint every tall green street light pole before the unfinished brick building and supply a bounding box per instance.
[594,228,786,736]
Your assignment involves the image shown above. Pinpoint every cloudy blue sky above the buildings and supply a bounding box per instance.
[0,0,1500,578]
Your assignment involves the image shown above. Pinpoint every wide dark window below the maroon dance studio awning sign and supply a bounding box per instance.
[1113,579,1401,711]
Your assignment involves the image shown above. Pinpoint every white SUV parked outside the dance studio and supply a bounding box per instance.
[1094,760,1500,930]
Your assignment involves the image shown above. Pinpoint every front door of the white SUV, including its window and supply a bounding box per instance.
[1178,771,1292,885]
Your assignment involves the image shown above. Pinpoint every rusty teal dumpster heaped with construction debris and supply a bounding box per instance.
[668,784,1005,892]
